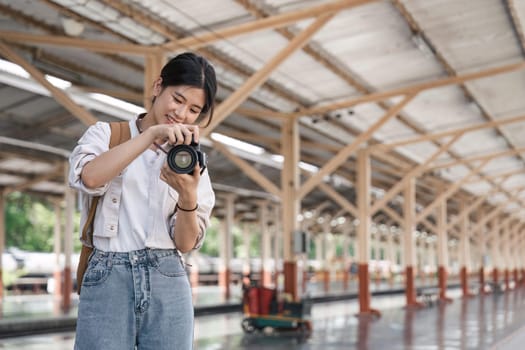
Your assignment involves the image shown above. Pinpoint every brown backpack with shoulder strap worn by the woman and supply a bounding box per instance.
[77,121,131,295]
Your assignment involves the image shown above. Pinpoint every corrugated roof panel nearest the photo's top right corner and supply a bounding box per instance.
[404,0,522,72]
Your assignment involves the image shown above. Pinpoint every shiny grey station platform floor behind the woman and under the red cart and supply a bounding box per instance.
[0,285,525,350]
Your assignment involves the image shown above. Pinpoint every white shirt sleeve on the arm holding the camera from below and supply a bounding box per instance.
[170,169,215,250]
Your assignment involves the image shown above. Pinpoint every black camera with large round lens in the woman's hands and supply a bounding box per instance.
[166,140,207,175]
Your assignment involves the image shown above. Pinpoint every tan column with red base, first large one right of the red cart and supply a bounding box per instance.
[356,148,380,315]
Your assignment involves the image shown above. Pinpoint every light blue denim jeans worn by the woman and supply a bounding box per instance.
[75,249,193,350]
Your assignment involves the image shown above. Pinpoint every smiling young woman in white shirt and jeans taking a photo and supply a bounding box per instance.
[69,53,217,350]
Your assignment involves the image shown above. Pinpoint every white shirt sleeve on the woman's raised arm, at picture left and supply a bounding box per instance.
[69,122,111,196]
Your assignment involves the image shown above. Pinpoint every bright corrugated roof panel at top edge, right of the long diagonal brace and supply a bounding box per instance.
[314,2,443,89]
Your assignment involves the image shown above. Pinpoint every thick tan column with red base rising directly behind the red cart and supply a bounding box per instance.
[281,118,300,300]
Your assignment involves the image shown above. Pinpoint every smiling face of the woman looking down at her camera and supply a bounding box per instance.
[151,83,205,124]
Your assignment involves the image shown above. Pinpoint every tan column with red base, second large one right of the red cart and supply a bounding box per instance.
[403,178,421,307]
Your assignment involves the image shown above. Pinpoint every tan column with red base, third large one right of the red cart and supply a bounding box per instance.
[437,198,452,301]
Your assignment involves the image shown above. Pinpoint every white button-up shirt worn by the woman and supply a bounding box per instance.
[69,121,215,252]
